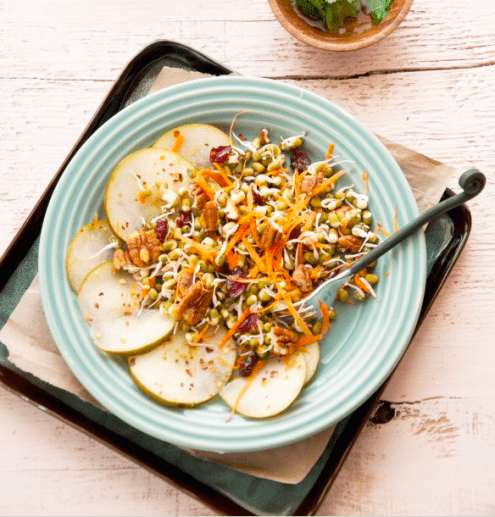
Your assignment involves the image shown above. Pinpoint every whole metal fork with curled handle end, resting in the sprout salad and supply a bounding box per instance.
[303,169,486,310]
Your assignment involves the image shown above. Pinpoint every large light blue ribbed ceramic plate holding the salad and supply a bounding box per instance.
[39,77,426,452]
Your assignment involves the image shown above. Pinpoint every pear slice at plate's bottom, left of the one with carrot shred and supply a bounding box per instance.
[128,330,236,407]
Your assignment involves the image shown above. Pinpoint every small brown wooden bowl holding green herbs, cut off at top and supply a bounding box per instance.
[268,0,413,52]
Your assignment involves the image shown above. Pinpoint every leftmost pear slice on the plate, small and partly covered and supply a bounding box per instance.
[65,220,117,293]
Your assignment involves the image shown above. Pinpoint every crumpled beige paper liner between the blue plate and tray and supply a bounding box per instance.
[0,67,454,484]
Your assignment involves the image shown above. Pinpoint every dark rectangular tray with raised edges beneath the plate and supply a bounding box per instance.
[0,41,471,515]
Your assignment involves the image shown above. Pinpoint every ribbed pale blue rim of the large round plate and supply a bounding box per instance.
[39,76,426,452]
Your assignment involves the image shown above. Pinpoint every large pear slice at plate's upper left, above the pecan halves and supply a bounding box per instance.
[104,147,195,240]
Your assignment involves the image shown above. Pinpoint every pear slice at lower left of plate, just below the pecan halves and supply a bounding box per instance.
[78,262,175,355]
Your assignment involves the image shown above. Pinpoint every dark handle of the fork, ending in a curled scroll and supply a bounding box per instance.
[347,169,486,275]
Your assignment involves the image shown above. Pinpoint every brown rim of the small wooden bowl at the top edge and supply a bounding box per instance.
[268,0,414,52]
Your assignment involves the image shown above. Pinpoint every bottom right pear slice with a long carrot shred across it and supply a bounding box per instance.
[220,353,306,418]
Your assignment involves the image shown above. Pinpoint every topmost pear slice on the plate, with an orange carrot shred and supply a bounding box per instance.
[153,124,230,169]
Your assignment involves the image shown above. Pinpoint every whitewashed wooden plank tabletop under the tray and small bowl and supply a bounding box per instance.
[0,0,495,515]
